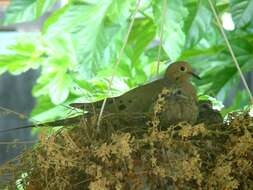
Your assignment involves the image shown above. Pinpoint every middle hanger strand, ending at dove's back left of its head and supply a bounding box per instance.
[156,0,167,75]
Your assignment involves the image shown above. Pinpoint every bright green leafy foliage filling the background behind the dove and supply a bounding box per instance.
[0,0,253,121]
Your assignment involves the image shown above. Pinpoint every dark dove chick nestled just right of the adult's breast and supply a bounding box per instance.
[197,100,223,125]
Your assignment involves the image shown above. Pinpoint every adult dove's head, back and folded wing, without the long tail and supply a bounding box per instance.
[70,61,199,112]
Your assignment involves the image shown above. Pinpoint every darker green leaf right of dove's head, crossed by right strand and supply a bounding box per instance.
[185,34,253,104]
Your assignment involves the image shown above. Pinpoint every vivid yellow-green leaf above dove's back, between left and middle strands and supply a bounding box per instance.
[95,17,156,88]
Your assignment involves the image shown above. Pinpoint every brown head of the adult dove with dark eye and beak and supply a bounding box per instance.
[165,61,200,83]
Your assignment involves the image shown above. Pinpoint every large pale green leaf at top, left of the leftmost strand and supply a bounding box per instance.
[44,0,132,79]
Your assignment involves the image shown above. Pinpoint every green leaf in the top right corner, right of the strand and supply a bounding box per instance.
[230,0,253,28]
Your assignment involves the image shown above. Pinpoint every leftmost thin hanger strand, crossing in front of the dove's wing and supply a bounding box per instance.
[97,0,141,128]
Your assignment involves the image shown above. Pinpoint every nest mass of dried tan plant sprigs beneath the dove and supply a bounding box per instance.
[0,107,253,190]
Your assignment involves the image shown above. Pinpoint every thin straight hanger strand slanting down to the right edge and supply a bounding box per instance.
[208,0,253,104]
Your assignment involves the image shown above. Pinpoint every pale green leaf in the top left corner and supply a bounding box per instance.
[3,0,57,25]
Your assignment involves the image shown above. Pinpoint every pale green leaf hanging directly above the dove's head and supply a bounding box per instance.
[153,0,188,60]
